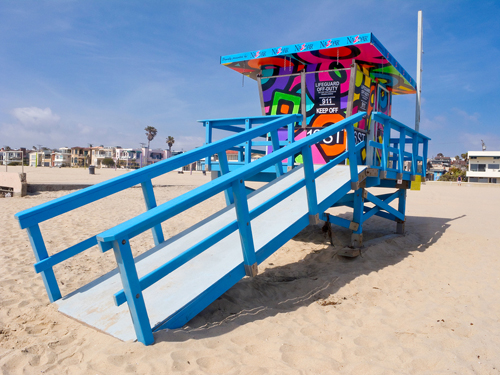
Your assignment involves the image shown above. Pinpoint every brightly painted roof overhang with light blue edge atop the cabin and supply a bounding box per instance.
[220,33,416,94]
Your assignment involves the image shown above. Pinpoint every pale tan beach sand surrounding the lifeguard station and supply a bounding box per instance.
[0,168,500,374]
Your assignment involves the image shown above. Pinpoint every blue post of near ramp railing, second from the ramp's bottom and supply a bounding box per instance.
[232,180,258,277]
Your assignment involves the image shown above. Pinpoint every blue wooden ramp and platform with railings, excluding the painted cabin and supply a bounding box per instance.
[16,112,429,345]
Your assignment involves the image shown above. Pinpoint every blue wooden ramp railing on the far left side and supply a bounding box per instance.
[15,115,302,302]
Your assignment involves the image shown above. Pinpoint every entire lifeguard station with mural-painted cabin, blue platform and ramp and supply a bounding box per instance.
[16,34,429,345]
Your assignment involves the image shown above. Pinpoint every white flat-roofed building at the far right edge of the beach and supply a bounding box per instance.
[467,151,500,184]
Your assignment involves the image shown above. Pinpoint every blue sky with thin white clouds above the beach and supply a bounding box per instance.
[0,0,500,156]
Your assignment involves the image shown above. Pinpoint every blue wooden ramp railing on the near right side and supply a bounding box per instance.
[97,112,365,345]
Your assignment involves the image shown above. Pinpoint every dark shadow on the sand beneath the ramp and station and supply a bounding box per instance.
[155,214,463,342]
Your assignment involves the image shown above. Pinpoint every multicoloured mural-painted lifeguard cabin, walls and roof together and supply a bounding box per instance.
[225,34,400,164]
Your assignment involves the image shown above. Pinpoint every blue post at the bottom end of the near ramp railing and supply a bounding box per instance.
[113,238,154,345]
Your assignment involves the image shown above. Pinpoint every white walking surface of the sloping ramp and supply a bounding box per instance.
[55,165,366,341]
